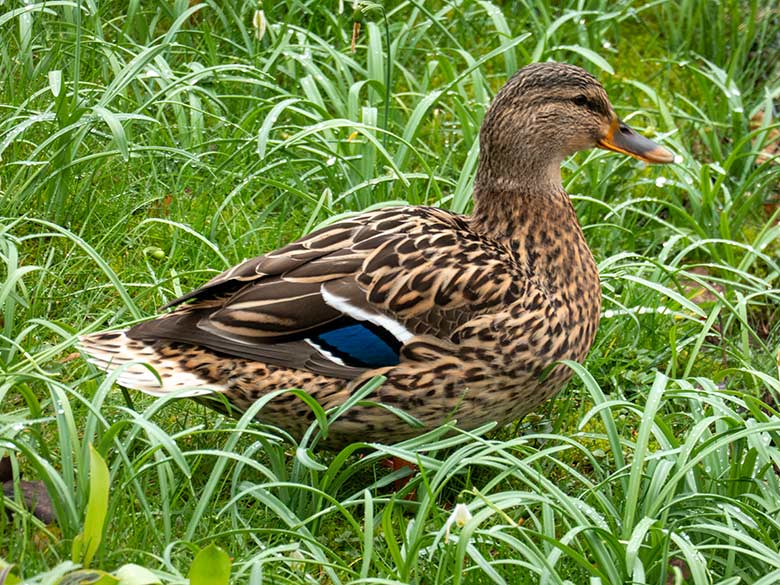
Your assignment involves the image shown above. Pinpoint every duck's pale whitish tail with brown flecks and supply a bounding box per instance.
[78,330,223,397]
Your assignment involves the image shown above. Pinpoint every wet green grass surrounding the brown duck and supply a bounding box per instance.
[0,0,780,585]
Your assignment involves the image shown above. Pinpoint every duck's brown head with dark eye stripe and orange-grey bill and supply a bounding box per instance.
[477,63,674,188]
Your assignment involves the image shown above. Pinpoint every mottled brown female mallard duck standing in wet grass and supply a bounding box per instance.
[81,63,673,445]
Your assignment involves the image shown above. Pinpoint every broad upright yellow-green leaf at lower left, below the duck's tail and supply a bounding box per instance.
[71,445,109,567]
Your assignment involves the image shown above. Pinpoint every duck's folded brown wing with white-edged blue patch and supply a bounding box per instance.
[127,208,511,379]
